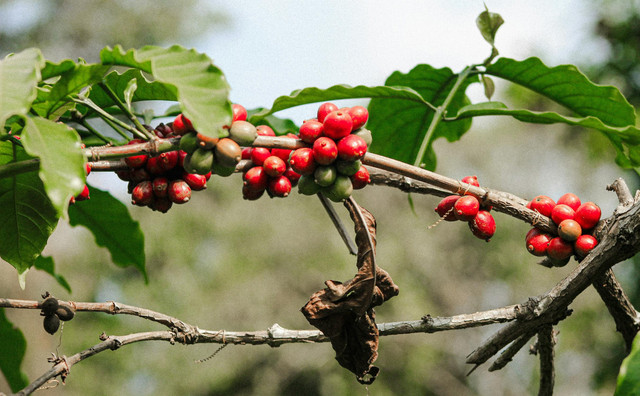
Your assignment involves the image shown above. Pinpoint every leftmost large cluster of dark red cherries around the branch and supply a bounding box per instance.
[116,122,220,213]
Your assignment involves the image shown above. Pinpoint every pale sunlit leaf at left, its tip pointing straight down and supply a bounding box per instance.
[22,117,85,217]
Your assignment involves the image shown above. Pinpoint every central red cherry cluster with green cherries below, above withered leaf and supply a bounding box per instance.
[289,102,371,202]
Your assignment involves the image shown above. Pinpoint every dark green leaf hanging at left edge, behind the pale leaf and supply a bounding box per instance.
[0,142,58,274]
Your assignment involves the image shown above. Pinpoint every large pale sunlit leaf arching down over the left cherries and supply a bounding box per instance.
[100,45,231,137]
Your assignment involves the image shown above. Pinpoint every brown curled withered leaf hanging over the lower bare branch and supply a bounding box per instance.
[301,198,398,384]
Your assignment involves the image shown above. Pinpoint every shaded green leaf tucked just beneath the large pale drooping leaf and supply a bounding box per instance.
[89,69,178,108]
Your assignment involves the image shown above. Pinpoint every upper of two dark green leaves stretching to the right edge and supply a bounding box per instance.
[486,58,636,127]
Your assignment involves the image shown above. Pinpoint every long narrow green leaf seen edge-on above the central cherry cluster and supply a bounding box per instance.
[250,84,428,124]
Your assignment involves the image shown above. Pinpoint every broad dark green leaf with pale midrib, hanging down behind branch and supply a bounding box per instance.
[367,65,478,170]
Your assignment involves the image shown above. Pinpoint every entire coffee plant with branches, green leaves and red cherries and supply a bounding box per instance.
[0,7,640,395]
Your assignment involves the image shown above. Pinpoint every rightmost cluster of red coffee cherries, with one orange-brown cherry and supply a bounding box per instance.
[525,193,601,267]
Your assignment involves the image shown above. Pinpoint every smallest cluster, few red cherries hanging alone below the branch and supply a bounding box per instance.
[435,176,496,242]
